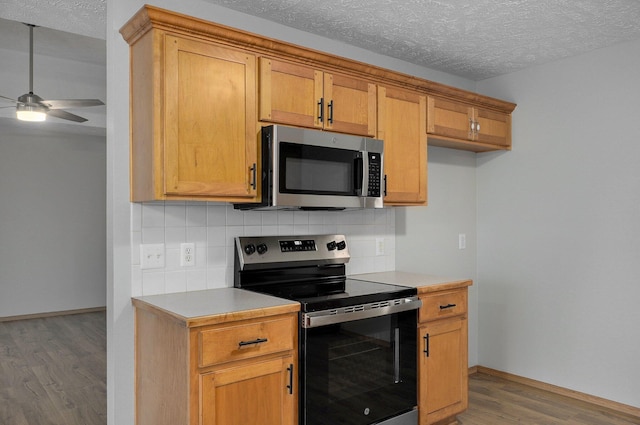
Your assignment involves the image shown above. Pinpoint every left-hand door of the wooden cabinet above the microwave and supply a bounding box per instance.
[259,58,324,128]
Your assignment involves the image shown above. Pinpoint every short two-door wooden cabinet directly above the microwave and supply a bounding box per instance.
[259,57,376,137]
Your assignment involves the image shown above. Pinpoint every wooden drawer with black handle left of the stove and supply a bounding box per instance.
[198,315,297,367]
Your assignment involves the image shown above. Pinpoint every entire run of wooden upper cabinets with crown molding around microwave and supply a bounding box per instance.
[120,5,516,205]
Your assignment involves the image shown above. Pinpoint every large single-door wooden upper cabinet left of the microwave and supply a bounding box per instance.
[121,19,257,202]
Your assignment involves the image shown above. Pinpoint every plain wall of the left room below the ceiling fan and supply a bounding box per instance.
[0,126,106,317]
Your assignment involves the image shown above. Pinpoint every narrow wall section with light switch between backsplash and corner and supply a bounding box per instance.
[396,146,478,366]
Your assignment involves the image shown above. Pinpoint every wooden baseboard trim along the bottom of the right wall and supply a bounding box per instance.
[469,366,640,418]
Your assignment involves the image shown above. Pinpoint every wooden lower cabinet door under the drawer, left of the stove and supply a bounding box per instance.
[200,356,297,425]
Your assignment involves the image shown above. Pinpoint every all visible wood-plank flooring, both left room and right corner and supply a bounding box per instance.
[0,312,640,425]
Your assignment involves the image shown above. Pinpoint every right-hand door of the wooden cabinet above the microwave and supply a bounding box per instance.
[324,73,377,137]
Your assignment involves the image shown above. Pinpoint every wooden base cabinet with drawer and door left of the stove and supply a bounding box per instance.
[134,289,299,425]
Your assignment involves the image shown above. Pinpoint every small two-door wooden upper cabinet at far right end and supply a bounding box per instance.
[427,96,511,152]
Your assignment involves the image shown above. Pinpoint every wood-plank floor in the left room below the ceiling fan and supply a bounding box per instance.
[0,311,107,425]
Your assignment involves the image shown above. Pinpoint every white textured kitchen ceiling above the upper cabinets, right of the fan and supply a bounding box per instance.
[202,0,640,80]
